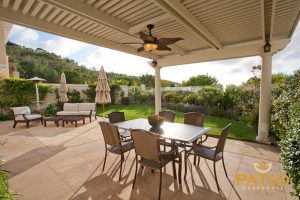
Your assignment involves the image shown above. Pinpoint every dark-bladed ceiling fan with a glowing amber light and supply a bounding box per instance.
[124,24,183,52]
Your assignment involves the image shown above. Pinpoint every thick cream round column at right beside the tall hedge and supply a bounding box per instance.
[256,52,272,143]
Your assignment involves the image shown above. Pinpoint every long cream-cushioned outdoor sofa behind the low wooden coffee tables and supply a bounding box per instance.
[56,103,97,122]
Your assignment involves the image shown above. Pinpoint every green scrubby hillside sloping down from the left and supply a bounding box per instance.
[6,41,177,87]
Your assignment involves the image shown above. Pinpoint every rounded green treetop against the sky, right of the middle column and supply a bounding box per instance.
[182,74,218,86]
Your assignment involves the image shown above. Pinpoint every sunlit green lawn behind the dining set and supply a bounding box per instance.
[97,105,256,141]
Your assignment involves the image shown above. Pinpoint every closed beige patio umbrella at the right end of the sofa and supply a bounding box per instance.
[95,66,111,121]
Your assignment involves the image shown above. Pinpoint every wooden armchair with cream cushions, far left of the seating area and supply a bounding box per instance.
[11,106,43,128]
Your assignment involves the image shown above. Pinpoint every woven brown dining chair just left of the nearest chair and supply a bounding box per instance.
[99,122,133,180]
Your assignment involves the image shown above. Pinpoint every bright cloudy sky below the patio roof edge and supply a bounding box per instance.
[8,25,300,86]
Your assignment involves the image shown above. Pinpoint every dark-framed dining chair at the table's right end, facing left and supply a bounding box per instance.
[184,124,231,191]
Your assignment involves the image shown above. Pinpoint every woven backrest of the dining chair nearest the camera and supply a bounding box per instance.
[130,129,160,162]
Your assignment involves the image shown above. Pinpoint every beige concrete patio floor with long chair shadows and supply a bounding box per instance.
[0,121,293,200]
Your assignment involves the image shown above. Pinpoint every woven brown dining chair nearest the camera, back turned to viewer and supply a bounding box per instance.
[130,129,182,199]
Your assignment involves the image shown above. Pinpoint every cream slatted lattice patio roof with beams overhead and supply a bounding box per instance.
[0,0,300,66]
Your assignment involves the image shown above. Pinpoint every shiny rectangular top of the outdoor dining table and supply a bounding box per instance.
[114,118,211,143]
